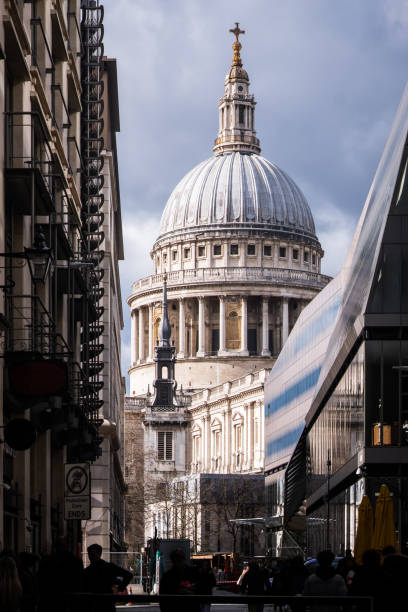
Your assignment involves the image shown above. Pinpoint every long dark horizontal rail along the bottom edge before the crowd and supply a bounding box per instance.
[64,593,374,612]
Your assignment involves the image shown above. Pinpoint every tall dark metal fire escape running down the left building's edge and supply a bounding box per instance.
[80,0,104,452]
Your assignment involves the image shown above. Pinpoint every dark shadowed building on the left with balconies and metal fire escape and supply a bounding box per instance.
[0,0,121,553]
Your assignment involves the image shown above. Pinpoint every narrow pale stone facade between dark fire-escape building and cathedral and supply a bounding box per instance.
[84,57,126,558]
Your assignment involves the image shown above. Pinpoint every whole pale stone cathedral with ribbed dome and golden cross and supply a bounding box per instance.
[125,24,330,548]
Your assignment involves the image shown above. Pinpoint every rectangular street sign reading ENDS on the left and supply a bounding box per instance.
[64,463,91,521]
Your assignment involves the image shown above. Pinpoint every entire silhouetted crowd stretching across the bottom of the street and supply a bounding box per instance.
[0,538,408,612]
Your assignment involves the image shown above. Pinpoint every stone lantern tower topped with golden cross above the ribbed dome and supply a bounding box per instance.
[213,22,261,155]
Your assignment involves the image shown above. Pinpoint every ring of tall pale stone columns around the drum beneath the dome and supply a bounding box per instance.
[131,295,301,365]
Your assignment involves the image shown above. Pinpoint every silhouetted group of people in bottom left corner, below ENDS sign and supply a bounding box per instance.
[0,538,133,612]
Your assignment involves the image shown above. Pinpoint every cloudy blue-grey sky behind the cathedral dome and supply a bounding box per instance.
[104,0,408,384]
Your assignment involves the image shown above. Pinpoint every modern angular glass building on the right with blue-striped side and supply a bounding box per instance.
[265,80,408,554]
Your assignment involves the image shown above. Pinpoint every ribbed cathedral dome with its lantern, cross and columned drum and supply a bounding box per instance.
[128,23,330,396]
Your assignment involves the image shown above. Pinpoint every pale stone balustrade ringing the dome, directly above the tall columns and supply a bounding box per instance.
[132,268,331,293]
